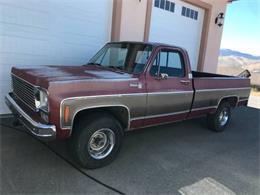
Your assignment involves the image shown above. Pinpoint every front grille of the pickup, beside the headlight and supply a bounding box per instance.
[12,75,36,110]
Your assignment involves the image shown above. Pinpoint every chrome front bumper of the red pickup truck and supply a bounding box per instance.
[5,93,56,141]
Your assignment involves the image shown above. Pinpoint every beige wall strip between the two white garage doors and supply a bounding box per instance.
[120,0,147,41]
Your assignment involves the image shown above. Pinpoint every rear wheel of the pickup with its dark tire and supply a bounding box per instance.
[207,102,231,132]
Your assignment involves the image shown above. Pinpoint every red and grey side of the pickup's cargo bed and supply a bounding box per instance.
[192,71,250,110]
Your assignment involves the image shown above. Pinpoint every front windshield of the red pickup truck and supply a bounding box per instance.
[87,43,153,74]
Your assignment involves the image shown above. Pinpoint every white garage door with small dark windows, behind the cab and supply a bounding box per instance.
[149,0,204,70]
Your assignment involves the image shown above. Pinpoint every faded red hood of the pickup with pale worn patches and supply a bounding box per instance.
[12,66,132,88]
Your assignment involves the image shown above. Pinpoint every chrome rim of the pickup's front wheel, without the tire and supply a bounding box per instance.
[88,128,115,159]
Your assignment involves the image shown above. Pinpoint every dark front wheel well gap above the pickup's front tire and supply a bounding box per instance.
[73,106,130,129]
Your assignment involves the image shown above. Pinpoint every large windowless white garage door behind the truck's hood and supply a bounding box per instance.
[0,0,113,114]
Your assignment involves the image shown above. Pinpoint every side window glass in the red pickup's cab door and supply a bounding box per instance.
[150,49,185,77]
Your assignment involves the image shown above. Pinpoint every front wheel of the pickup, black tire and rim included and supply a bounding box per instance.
[71,113,123,169]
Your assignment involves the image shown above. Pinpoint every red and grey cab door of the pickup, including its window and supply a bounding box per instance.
[144,47,193,126]
